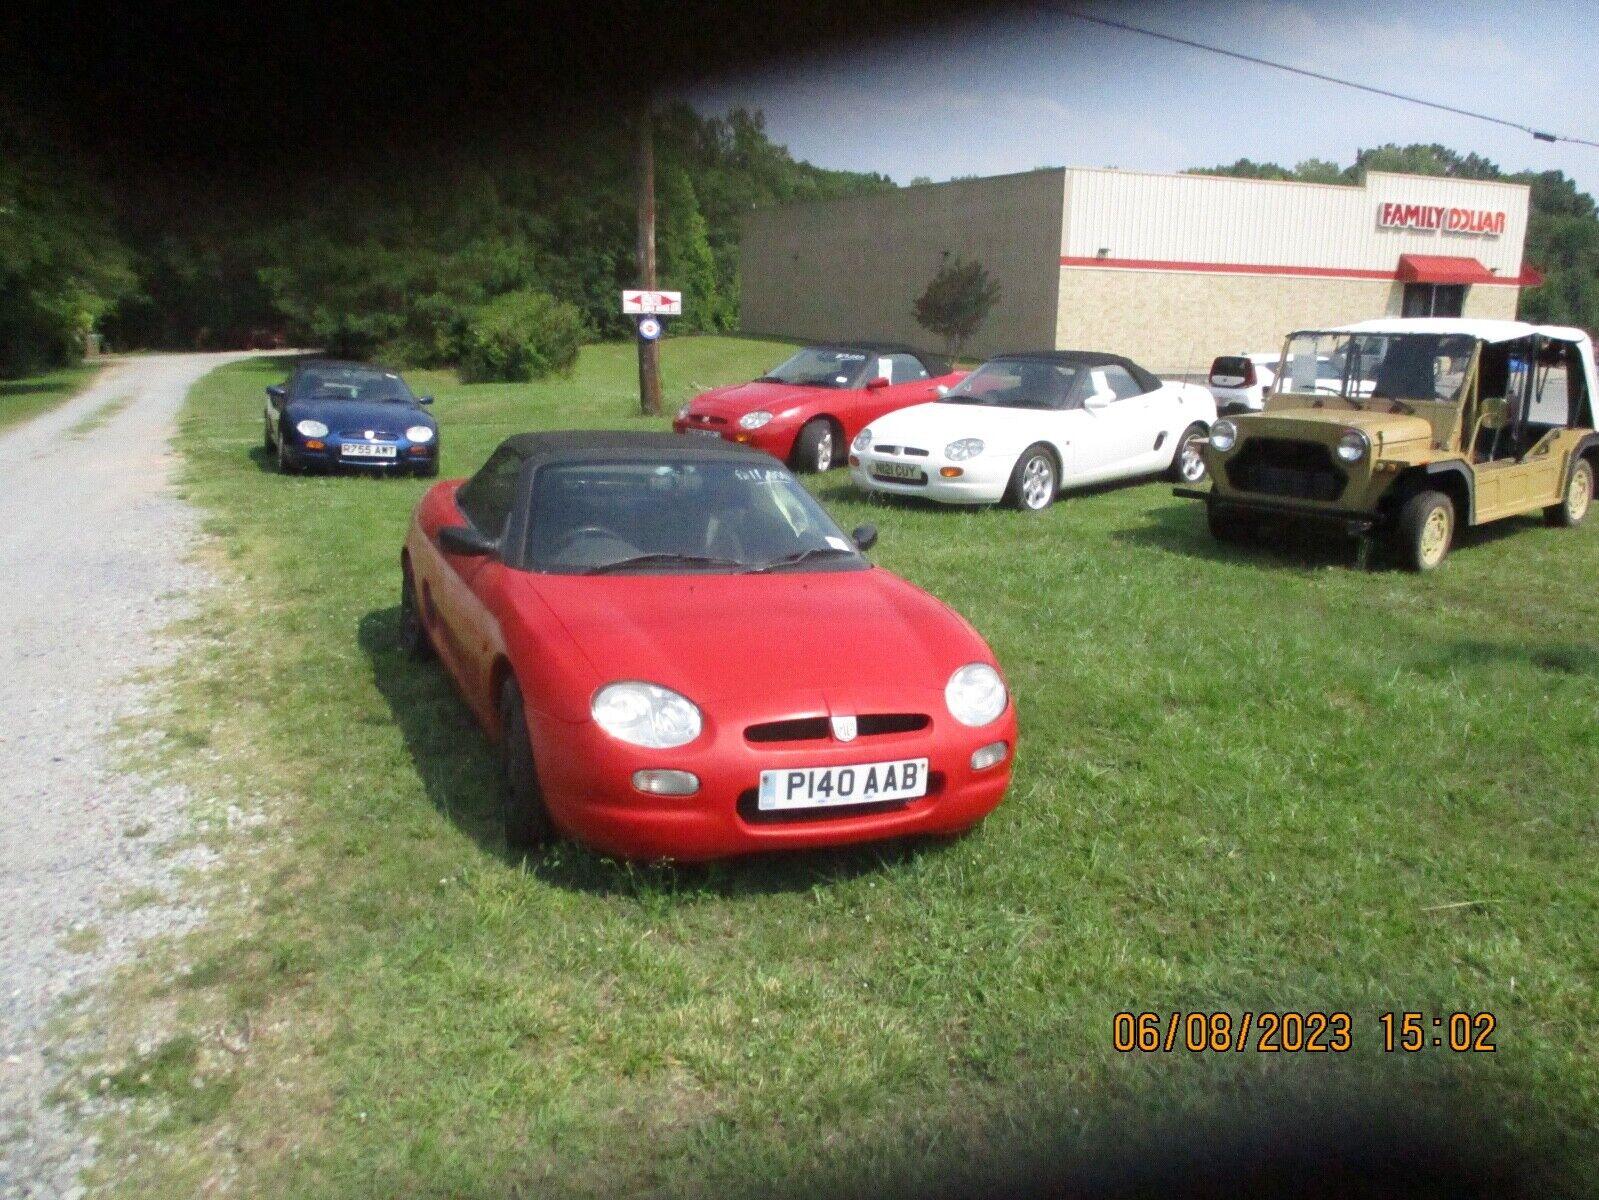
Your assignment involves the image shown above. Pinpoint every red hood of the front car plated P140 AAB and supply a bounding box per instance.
[516,568,993,712]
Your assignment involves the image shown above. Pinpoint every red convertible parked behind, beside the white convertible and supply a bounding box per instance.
[672,342,966,470]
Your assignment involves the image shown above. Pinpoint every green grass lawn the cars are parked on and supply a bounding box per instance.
[88,338,1599,1197]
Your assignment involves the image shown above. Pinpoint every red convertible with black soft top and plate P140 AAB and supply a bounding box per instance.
[400,432,1015,861]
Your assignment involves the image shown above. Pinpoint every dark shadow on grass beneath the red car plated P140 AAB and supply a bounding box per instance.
[357,604,950,899]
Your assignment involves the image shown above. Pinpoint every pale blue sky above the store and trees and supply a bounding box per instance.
[683,0,1599,195]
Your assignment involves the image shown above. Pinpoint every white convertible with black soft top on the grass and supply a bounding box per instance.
[849,350,1215,512]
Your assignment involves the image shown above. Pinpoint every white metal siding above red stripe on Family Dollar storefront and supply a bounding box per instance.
[1062,168,1529,277]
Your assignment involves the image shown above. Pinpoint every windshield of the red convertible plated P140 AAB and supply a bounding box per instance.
[528,458,868,574]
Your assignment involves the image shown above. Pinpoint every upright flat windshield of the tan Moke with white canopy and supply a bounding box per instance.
[1276,333,1476,403]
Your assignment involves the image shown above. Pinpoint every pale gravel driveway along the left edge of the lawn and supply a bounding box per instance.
[0,354,273,1200]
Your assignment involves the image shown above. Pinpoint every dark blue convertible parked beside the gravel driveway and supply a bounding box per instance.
[262,360,438,475]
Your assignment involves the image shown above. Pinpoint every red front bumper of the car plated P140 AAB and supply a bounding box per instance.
[531,696,1015,862]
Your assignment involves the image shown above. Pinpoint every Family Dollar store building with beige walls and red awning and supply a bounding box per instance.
[740,168,1540,373]
